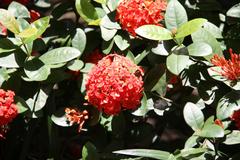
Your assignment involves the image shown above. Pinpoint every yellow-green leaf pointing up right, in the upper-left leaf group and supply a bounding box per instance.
[23,16,50,44]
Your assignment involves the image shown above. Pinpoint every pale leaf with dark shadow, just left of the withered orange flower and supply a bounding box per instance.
[51,108,73,127]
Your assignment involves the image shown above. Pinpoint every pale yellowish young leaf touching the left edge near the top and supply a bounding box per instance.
[0,9,19,34]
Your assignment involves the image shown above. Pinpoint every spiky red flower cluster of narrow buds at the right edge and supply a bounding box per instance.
[211,49,240,81]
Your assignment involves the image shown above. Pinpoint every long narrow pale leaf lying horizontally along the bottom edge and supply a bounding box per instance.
[113,149,171,160]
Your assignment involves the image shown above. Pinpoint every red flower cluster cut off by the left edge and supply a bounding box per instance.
[0,89,18,126]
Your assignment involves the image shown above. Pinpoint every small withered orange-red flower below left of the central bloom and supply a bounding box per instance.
[65,108,88,132]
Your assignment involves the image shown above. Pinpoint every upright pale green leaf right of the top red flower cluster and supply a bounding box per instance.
[165,0,188,31]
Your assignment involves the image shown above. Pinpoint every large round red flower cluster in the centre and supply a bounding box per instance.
[86,54,143,115]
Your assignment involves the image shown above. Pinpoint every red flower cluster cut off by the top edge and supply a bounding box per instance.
[116,0,167,36]
